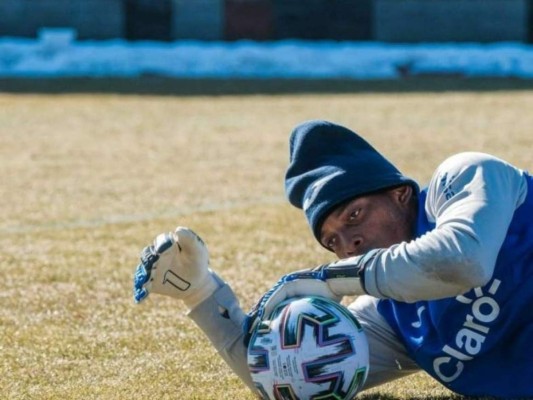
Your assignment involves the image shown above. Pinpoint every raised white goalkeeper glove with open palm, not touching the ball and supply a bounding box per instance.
[133,227,219,309]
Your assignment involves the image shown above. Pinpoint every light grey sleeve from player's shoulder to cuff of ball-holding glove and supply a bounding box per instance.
[365,152,527,302]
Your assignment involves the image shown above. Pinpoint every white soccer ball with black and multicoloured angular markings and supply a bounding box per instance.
[247,297,368,400]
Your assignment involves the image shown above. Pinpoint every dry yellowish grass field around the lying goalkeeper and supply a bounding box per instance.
[0,79,533,400]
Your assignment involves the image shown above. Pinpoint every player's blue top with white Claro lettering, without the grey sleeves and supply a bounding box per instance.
[378,175,533,398]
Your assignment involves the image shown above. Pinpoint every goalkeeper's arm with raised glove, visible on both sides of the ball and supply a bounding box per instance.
[133,227,424,392]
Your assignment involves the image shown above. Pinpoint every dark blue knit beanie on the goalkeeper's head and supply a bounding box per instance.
[285,121,419,242]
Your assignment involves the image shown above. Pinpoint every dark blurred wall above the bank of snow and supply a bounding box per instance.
[0,0,533,43]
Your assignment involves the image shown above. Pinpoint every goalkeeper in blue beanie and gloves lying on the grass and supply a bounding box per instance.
[135,121,533,398]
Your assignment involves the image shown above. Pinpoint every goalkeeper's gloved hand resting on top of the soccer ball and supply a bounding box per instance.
[245,249,383,342]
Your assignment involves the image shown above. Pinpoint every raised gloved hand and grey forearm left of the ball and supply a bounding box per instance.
[133,227,255,391]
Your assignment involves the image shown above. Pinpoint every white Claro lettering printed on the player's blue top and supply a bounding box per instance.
[433,279,501,383]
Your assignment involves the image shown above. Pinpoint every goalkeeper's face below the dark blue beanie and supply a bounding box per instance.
[320,186,416,258]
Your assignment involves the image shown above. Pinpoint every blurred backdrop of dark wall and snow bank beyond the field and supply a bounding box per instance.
[0,0,533,82]
